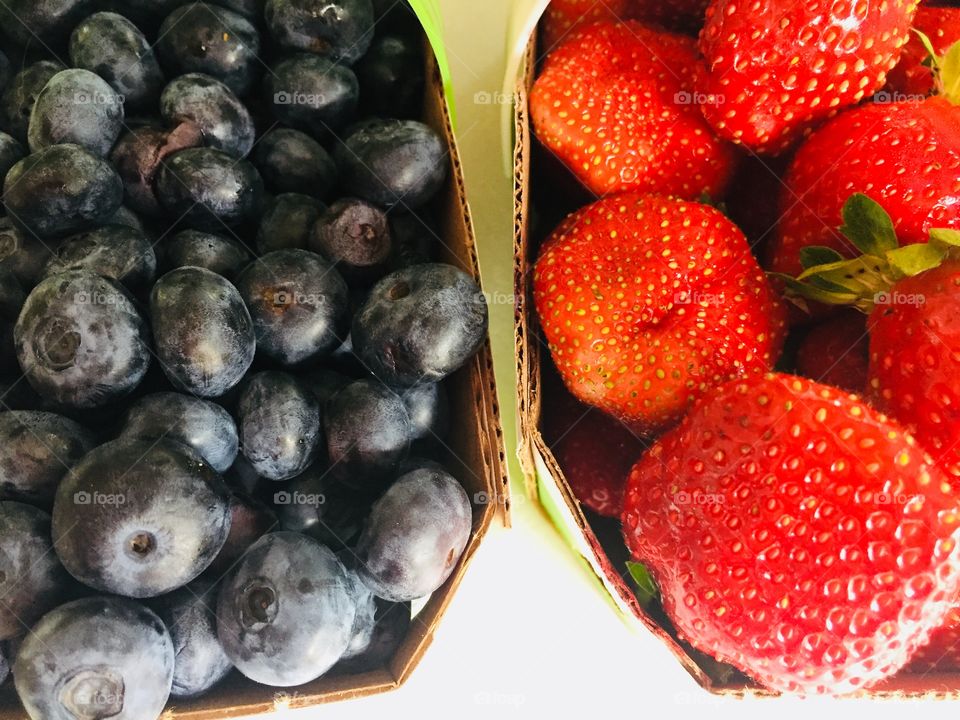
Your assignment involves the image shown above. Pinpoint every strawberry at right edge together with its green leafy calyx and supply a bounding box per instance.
[788,194,960,480]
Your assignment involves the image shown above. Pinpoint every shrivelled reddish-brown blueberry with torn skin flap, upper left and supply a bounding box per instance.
[110,123,203,217]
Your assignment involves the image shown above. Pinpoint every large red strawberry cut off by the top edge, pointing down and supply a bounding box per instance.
[698,0,917,154]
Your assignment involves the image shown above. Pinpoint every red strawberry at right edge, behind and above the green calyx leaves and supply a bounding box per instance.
[768,97,960,275]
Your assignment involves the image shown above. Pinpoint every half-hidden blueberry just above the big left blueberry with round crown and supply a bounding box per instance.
[42,225,157,293]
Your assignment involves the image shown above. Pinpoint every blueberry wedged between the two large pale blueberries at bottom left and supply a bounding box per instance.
[157,579,233,698]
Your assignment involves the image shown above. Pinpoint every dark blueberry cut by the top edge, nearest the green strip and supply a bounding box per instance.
[264,0,374,65]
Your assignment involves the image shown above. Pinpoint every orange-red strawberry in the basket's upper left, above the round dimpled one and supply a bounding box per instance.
[530,22,735,198]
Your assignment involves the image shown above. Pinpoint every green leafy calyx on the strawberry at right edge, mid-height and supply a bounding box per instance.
[770,193,960,313]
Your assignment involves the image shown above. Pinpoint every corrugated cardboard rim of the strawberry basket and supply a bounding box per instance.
[514,23,960,699]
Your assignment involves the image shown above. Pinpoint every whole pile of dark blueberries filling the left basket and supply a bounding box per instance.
[0,0,487,720]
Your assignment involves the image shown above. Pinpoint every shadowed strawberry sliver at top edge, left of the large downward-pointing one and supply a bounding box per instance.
[542,0,709,54]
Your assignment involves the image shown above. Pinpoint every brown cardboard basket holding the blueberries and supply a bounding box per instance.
[0,28,508,720]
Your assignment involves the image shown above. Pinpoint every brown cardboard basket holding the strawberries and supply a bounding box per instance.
[507,9,960,698]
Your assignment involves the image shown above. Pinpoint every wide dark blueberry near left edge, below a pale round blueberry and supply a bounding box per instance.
[3,144,123,238]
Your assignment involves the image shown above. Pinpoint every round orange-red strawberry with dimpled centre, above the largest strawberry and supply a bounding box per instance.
[533,194,785,433]
